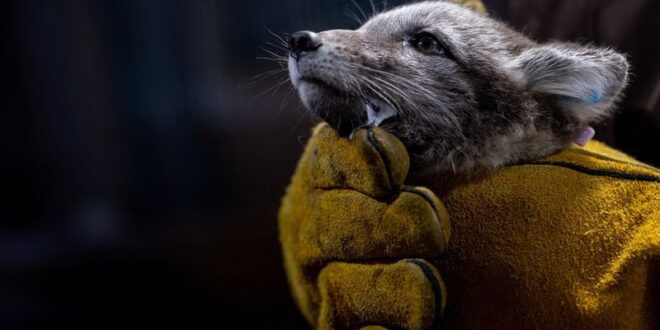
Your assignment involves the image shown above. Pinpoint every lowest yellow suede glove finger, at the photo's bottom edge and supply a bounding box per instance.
[317,259,446,329]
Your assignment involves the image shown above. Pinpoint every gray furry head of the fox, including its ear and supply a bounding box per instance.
[289,1,628,173]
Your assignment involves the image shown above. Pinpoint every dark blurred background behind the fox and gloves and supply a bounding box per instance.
[0,0,660,329]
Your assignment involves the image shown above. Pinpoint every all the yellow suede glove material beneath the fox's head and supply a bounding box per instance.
[279,124,660,329]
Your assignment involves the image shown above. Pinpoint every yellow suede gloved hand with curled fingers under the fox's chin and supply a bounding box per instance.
[279,124,450,329]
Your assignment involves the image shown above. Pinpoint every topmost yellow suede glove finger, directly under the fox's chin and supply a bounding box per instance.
[301,124,410,199]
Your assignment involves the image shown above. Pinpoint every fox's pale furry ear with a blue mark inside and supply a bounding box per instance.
[511,43,629,124]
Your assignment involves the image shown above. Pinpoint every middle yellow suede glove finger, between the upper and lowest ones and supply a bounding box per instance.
[297,187,450,266]
